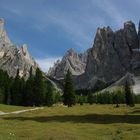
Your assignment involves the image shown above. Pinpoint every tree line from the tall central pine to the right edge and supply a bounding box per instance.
[63,70,140,107]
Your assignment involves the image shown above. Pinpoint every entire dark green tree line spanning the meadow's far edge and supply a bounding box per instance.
[0,68,140,107]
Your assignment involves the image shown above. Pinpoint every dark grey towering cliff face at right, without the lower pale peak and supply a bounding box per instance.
[74,21,140,89]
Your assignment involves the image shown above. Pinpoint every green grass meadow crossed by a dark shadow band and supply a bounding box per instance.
[0,105,140,140]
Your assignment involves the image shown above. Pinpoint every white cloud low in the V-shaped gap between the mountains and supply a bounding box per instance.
[36,57,61,72]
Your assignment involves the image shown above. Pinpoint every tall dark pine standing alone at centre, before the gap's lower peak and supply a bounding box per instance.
[63,70,75,107]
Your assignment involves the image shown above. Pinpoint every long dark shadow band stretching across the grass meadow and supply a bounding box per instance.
[3,114,140,124]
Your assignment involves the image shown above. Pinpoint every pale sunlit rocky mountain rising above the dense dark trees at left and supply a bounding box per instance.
[0,19,38,78]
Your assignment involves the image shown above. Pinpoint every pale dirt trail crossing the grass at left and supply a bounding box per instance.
[0,107,43,116]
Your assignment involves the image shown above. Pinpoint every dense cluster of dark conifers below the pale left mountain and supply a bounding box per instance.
[0,68,61,106]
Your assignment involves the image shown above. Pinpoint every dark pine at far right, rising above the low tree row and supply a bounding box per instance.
[124,81,134,106]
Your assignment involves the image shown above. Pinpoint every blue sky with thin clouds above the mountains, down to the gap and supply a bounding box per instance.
[0,0,140,71]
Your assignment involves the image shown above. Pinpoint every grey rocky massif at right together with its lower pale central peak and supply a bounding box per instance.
[49,21,140,92]
